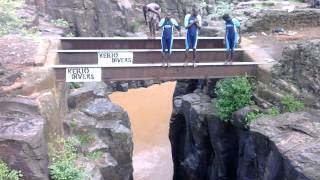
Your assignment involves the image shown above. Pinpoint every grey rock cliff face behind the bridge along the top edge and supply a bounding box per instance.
[41,0,214,37]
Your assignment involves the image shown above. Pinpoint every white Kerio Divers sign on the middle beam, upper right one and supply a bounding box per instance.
[98,51,133,66]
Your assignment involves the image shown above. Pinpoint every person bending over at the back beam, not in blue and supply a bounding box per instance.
[142,3,161,38]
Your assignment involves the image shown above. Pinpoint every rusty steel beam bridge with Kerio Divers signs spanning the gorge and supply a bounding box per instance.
[51,37,267,82]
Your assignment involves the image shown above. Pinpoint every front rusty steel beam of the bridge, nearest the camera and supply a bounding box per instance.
[52,62,257,81]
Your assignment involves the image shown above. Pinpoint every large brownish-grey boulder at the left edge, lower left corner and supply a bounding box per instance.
[0,98,48,180]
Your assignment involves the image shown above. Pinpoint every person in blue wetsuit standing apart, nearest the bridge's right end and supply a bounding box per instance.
[222,14,241,64]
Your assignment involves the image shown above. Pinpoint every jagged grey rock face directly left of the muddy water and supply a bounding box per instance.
[65,83,133,180]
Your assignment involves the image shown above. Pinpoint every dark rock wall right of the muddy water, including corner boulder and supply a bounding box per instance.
[169,87,320,180]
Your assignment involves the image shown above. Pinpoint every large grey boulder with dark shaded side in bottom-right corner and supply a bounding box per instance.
[238,112,320,180]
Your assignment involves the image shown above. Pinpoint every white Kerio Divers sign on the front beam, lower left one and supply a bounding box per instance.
[66,67,101,82]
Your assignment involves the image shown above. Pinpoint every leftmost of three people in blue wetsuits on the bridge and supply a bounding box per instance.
[159,13,181,67]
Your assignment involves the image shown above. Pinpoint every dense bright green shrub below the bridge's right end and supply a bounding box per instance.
[215,77,253,121]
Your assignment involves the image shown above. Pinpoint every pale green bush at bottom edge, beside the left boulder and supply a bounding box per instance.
[49,138,88,180]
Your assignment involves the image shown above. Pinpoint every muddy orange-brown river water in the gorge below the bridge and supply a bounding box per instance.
[110,82,175,180]
